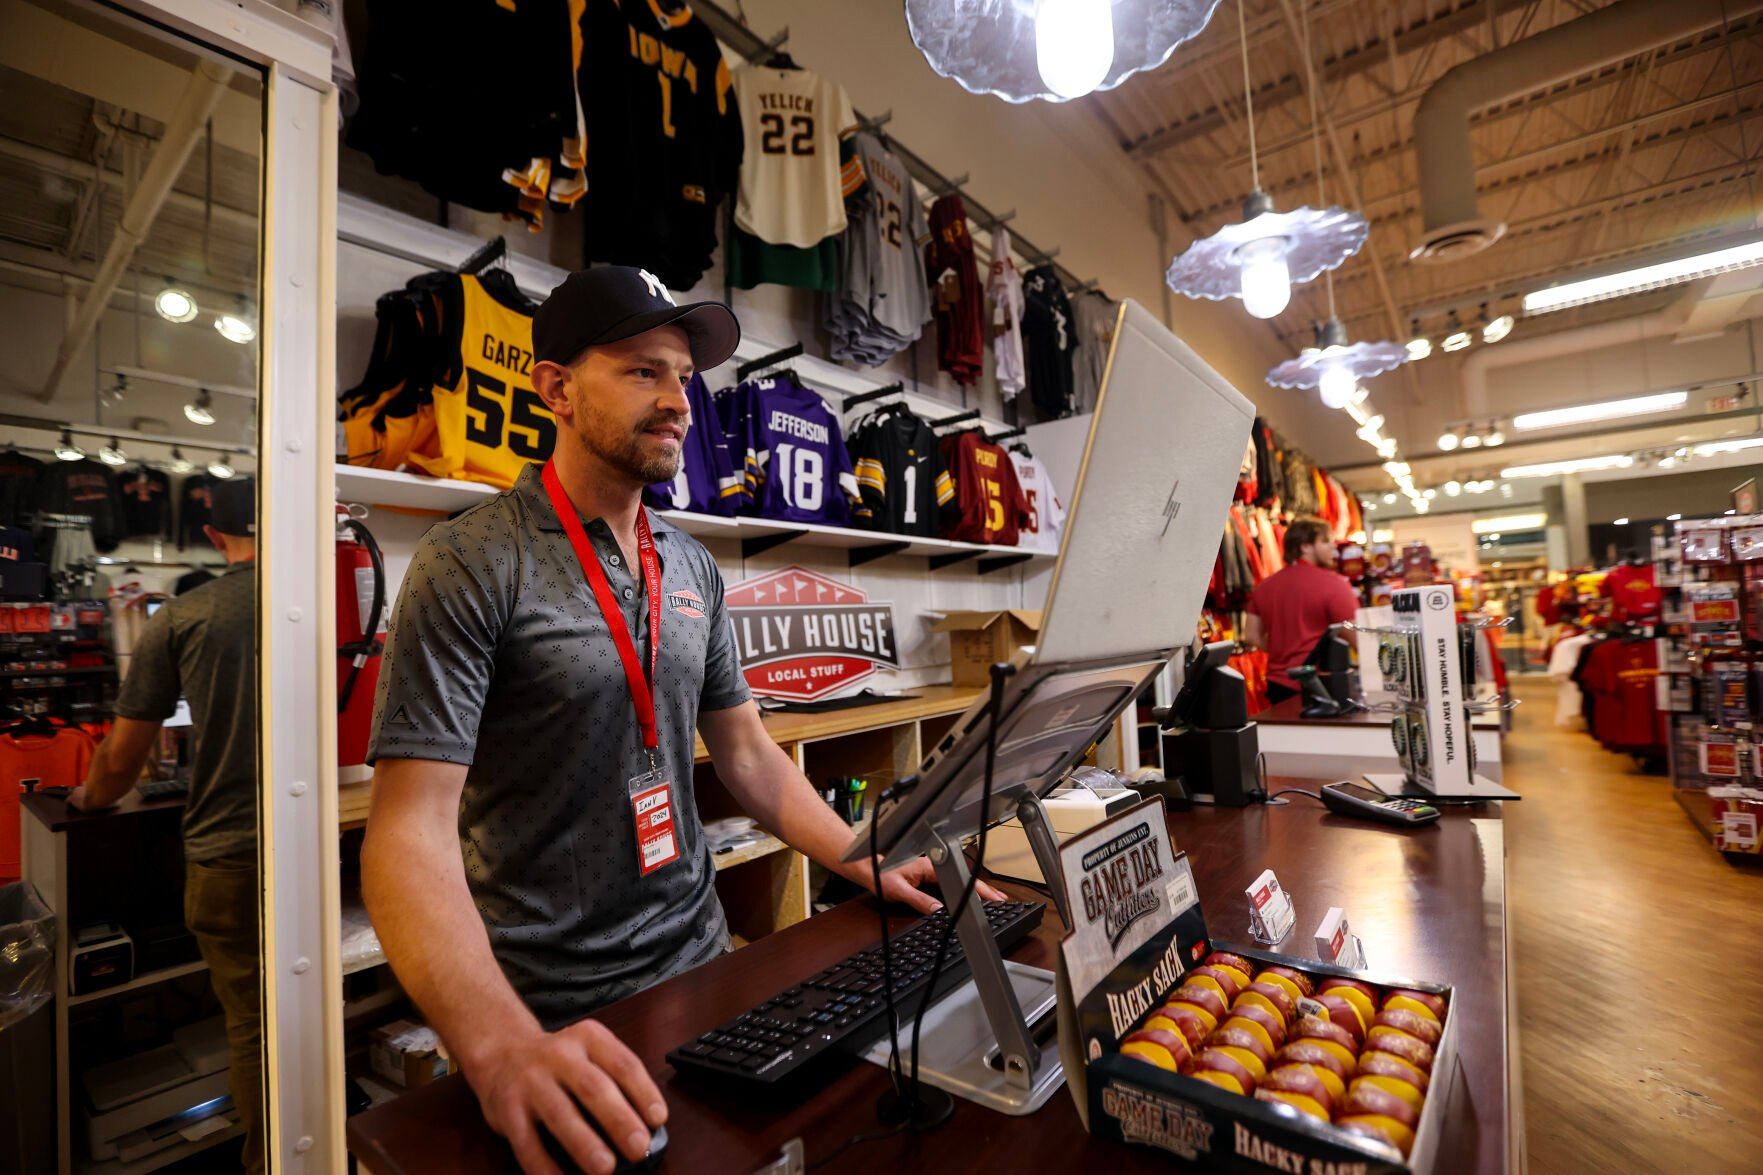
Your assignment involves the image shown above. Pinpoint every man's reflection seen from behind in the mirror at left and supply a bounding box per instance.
[67,478,264,1171]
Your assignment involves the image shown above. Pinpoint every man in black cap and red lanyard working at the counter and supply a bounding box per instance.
[361,266,1000,1171]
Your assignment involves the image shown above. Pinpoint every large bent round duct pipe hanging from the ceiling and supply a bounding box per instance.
[1410,0,1763,261]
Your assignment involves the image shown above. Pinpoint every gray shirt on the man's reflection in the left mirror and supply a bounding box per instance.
[116,563,257,861]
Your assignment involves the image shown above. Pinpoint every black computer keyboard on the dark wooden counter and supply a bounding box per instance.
[666,902,1045,1085]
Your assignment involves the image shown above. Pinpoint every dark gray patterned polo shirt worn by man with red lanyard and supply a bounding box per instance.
[368,466,749,1029]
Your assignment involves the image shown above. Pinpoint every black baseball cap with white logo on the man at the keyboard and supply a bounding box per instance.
[532,265,740,370]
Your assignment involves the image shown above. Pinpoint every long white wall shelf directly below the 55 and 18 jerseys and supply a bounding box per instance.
[337,466,1056,559]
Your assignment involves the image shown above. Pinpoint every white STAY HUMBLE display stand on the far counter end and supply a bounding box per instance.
[1349,584,1518,803]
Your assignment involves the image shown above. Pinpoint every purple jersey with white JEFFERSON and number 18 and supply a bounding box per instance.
[735,376,857,526]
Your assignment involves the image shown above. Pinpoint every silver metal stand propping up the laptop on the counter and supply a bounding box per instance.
[864,794,1070,1115]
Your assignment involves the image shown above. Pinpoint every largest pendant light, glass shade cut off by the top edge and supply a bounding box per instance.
[906,0,1220,102]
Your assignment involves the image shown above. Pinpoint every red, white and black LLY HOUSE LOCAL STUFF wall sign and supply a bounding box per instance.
[726,566,899,702]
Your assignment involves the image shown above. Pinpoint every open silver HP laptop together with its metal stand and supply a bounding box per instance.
[844,302,1255,1113]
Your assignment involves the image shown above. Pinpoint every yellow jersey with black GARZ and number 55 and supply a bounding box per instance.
[409,273,557,489]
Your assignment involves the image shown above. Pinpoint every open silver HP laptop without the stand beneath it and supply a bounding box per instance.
[844,300,1255,864]
